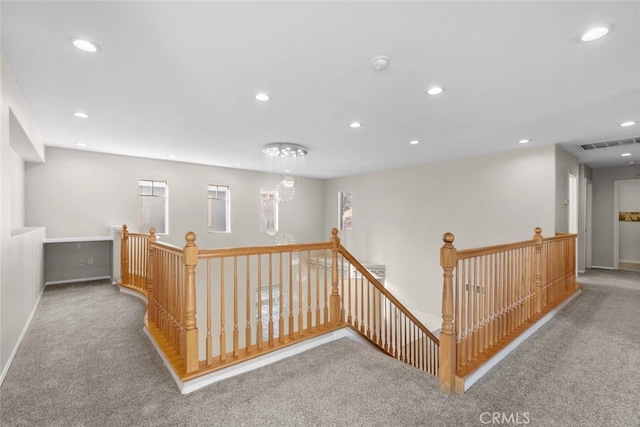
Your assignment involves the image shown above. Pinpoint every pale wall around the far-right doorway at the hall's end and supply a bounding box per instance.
[593,165,640,268]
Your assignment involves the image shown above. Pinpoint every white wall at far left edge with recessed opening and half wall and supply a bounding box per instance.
[0,57,44,382]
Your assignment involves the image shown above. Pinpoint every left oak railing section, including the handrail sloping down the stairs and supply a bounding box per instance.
[121,226,438,381]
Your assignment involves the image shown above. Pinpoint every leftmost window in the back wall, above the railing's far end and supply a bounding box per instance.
[138,180,169,234]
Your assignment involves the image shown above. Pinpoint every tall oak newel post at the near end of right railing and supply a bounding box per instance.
[438,233,457,395]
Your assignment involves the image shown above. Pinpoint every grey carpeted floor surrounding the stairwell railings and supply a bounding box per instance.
[0,270,640,427]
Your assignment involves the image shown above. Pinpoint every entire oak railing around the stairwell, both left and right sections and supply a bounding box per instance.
[121,226,576,394]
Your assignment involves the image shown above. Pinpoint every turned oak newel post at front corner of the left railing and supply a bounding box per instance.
[182,231,199,373]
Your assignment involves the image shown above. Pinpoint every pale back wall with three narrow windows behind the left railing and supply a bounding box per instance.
[26,147,331,248]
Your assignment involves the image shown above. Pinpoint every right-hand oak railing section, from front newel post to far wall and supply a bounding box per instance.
[439,228,576,394]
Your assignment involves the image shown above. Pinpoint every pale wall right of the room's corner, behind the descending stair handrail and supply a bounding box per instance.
[325,146,556,316]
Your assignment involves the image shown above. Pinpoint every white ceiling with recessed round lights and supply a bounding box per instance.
[0,0,640,178]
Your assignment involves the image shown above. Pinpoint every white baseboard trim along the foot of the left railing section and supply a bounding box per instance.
[143,326,378,394]
